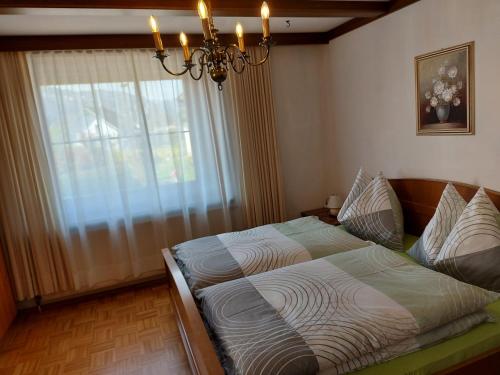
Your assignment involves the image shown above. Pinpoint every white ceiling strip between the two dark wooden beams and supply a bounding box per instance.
[0,0,389,36]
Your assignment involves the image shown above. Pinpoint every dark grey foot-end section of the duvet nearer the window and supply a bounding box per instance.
[172,236,244,289]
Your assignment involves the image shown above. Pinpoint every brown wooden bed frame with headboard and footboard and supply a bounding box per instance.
[162,178,500,375]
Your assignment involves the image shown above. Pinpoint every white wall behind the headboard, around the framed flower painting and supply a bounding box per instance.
[326,0,500,200]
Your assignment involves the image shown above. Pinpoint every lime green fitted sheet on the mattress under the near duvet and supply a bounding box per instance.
[353,245,500,375]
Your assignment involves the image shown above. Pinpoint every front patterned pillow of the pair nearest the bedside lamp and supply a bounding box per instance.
[340,173,404,250]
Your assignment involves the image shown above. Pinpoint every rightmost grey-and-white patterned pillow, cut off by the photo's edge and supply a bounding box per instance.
[434,188,500,292]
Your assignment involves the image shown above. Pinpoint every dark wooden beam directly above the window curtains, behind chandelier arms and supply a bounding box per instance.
[0,33,328,51]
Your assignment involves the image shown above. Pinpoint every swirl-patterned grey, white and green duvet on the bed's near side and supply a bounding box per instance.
[196,245,498,375]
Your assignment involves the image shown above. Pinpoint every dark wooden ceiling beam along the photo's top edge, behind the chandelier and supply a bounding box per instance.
[0,0,389,17]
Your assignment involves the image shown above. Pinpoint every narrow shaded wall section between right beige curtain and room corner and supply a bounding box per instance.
[271,45,328,218]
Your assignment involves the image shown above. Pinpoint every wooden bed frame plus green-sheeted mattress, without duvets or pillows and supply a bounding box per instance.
[163,179,500,375]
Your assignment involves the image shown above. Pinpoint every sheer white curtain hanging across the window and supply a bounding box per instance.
[28,50,242,289]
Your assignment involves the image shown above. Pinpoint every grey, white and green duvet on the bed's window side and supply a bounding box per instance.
[172,217,370,290]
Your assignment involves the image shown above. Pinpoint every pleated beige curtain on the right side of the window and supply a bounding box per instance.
[224,47,285,227]
